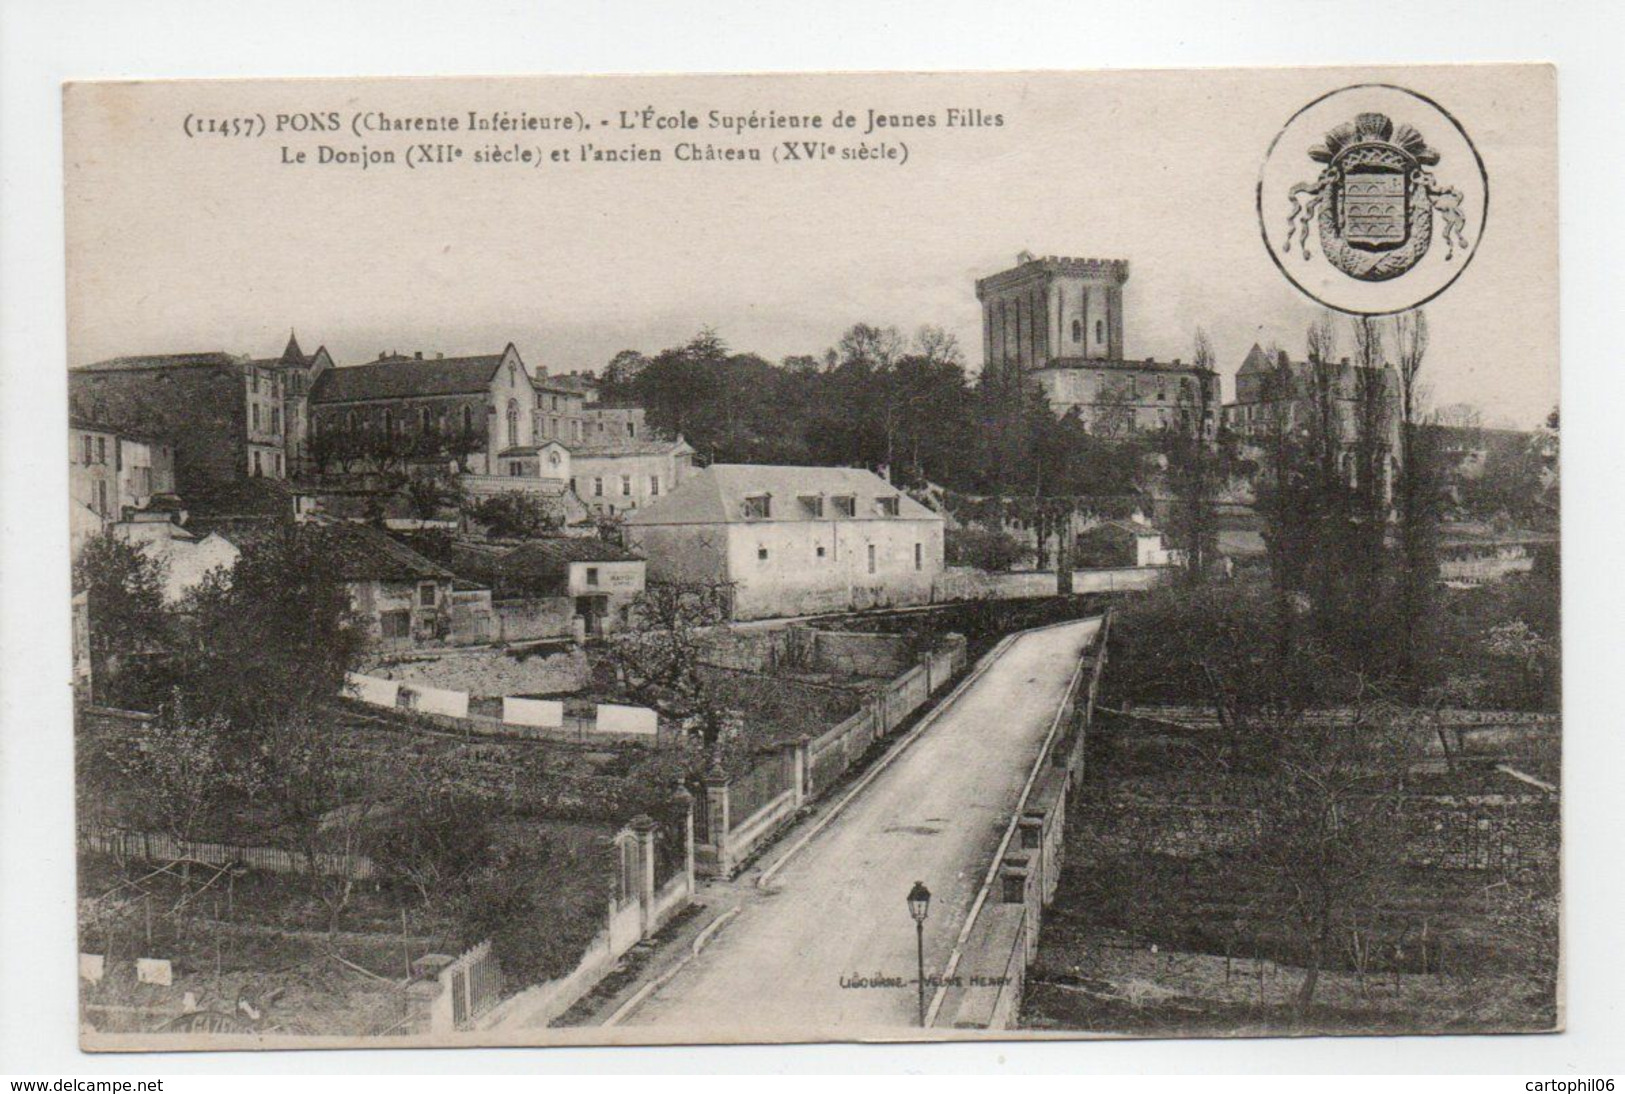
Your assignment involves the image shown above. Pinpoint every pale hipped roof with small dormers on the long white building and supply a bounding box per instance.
[626,463,943,525]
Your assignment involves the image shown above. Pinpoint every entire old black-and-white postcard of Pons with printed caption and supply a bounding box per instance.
[62,65,1563,1050]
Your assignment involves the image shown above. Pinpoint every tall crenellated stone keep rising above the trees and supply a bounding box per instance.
[977,252,1128,369]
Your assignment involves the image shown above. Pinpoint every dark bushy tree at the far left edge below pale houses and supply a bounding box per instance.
[73,532,171,704]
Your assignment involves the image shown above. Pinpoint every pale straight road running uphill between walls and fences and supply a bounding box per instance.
[626,619,1100,1040]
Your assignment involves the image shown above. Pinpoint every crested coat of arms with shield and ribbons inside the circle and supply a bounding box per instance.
[1282,112,1469,281]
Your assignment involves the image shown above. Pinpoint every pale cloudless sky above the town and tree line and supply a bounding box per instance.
[67,67,1558,428]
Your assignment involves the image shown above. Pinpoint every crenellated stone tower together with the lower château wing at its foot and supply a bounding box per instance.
[977,252,1220,436]
